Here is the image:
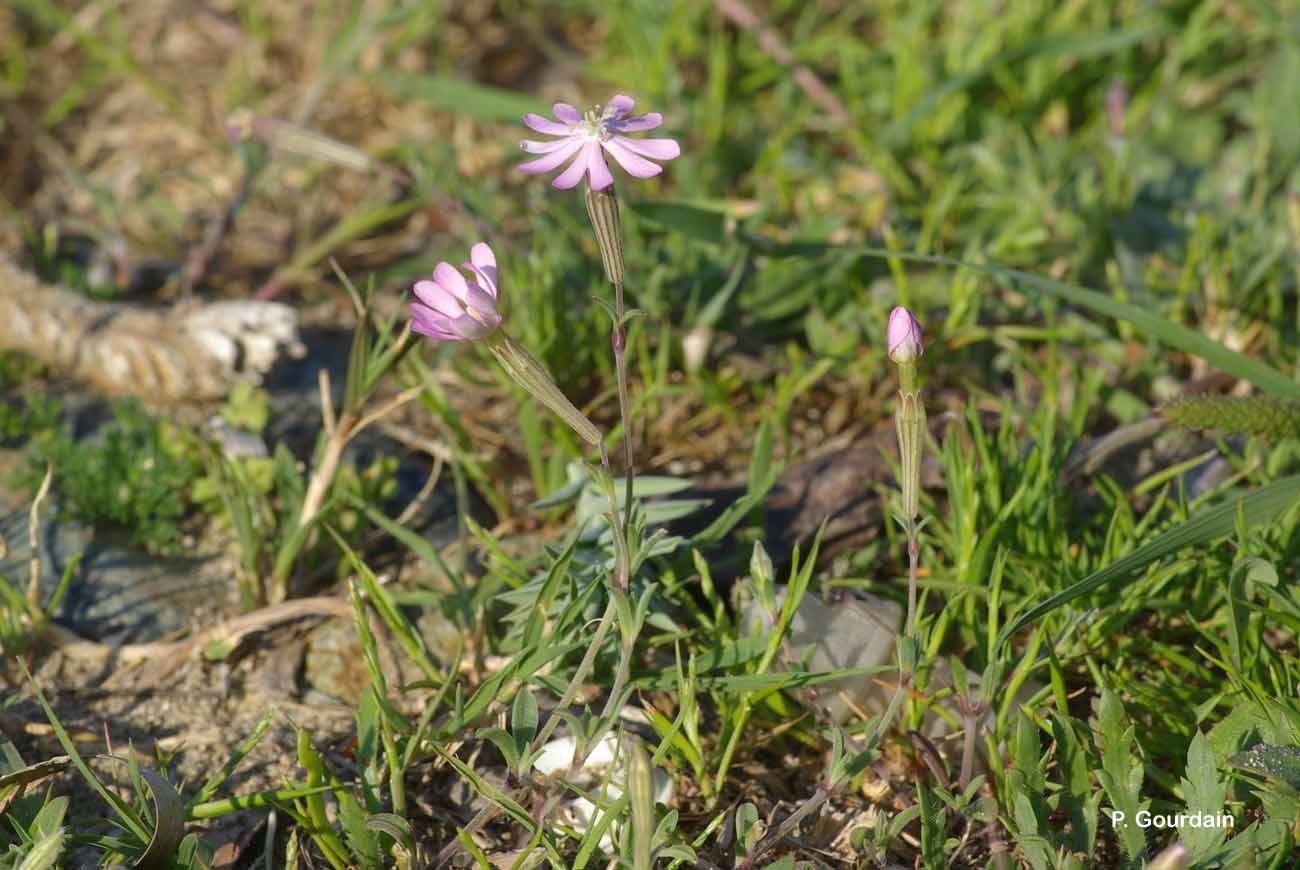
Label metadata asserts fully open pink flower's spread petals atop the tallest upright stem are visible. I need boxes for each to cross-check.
[519,94,681,190]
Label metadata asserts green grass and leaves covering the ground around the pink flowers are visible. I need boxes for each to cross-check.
[0,0,1300,869]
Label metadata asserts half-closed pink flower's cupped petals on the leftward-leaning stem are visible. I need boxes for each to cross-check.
[411,242,501,341]
